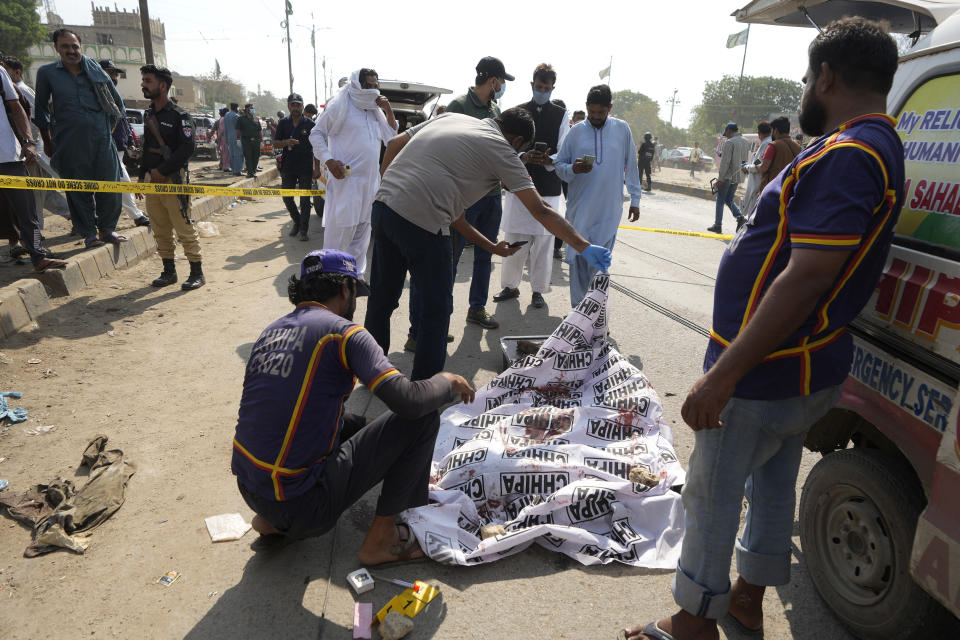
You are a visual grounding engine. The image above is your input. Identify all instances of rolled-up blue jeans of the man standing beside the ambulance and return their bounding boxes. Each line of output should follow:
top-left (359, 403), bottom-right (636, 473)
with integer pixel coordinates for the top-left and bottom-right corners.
top-left (673, 386), bottom-right (840, 619)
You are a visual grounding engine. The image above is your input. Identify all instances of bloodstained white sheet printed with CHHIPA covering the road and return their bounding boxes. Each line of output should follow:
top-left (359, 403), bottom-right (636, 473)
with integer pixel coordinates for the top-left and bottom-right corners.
top-left (403, 274), bottom-right (684, 569)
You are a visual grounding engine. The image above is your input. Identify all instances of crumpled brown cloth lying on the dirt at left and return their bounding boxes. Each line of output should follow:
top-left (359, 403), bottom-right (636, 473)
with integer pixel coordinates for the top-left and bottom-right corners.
top-left (0, 435), bottom-right (135, 558)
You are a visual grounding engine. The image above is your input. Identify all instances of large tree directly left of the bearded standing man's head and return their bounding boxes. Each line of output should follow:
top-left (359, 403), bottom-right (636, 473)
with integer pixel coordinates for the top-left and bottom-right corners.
top-left (690, 75), bottom-right (803, 149)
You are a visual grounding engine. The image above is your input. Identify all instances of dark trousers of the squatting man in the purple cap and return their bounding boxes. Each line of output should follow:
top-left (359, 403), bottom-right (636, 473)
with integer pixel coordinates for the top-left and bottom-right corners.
top-left (238, 404), bottom-right (440, 540)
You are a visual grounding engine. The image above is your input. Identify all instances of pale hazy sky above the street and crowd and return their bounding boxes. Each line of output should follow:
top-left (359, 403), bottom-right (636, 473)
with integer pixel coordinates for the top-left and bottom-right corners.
top-left (55, 0), bottom-right (816, 127)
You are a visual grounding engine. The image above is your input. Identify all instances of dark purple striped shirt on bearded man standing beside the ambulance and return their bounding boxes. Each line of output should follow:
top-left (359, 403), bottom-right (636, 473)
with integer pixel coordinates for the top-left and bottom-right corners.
top-left (704, 114), bottom-right (904, 400)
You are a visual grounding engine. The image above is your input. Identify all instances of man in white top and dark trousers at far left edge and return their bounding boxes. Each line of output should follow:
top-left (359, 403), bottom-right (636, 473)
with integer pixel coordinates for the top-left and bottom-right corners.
top-left (0, 61), bottom-right (67, 272)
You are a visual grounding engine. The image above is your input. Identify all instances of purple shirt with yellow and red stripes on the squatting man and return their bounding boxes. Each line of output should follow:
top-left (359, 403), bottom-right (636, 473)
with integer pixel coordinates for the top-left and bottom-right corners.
top-left (231, 302), bottom-right (400, 501)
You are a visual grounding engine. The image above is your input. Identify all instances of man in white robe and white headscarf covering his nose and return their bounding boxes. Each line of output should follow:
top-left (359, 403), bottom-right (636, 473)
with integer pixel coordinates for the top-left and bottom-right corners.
top-left (310, 69), bottom-right (397, 279)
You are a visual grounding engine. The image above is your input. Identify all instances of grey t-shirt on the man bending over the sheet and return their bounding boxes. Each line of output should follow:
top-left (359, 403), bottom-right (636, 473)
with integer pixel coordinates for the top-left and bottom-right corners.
top-left (376, 113), bottom-right (534, 235)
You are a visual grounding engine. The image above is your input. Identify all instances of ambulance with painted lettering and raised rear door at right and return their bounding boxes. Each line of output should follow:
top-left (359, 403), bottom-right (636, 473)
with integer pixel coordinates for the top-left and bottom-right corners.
top-left (733, 0), bottom-right (960, 640)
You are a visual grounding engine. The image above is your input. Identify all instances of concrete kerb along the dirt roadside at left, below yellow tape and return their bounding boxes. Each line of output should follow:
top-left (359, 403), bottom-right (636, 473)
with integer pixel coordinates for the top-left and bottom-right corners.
top-left (0, 167), bottom-right (279, 338)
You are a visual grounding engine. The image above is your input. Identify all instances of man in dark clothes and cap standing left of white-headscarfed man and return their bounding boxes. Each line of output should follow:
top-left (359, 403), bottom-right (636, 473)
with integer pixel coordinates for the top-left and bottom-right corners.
top-left (273, 93), bottom-right (314, 241)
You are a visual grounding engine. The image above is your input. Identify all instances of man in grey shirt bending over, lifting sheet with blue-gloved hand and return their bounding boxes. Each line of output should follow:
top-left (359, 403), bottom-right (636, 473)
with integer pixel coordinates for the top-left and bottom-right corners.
top-left (364, 108), bottom-right (610, 380)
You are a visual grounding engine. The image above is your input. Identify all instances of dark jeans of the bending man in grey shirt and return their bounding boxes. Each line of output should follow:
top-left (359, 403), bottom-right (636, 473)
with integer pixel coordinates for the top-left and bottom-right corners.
top-left (363, 201), bottom-right (453, 380)
